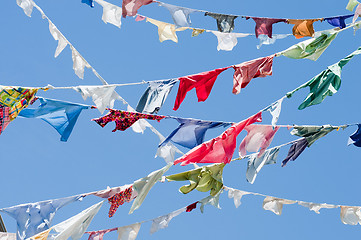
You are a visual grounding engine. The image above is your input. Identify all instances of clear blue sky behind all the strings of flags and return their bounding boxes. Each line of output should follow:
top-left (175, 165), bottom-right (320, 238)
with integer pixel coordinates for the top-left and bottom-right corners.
top-left (0, 0), bottom-right (361, 239)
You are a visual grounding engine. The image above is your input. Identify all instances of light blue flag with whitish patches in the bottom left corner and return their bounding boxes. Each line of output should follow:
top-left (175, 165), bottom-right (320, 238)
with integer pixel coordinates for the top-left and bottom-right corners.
top-left (0, 195), bottom-right (82, 240)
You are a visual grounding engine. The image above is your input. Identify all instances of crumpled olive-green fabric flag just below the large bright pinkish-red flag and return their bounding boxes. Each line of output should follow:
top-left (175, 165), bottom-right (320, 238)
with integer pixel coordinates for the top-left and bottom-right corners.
top-left (166, 163), bottom-right (225, 196)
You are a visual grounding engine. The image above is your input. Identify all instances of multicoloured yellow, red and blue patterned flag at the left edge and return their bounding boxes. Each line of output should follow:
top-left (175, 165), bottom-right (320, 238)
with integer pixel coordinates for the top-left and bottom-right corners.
top-left (0, 85), bottom-right (39, 121)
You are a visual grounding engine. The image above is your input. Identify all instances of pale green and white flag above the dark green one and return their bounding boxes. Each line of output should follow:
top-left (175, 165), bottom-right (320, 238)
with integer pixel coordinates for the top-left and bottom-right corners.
top-left (280, 30), bottom-right (338, 61)
